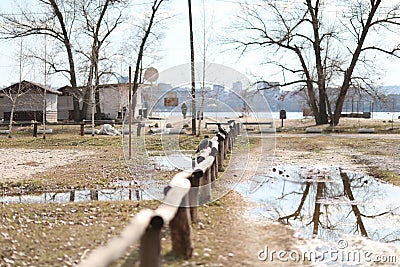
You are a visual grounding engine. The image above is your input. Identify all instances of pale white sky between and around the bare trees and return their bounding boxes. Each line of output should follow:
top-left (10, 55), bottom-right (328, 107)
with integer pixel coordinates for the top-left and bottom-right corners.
top-left (0, 0), bottom-right (400, 90)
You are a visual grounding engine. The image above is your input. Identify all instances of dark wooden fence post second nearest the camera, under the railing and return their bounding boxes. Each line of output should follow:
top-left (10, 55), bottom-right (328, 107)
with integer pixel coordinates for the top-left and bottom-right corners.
top-left (169, 195), bottom-right (193, 260)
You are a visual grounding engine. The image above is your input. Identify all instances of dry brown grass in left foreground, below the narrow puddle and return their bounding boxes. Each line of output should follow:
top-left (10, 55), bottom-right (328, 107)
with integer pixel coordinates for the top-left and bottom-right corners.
top-left (0, 201), bottom-right (158, 266)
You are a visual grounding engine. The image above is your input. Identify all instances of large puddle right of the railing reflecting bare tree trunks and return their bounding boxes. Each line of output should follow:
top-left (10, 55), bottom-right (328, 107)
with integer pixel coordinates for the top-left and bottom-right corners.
top-left (236, 165), bottom-right (400, 244)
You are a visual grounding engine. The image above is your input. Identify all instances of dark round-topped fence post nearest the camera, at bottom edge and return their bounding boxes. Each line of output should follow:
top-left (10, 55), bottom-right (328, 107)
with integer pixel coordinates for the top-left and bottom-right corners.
top-left (140, 216), bottom-right (164, 267)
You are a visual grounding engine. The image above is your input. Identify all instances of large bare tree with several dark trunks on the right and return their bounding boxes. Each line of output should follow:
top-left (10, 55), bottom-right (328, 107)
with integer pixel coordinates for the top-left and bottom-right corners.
top-left (232, 0), bottom-right (400, 125)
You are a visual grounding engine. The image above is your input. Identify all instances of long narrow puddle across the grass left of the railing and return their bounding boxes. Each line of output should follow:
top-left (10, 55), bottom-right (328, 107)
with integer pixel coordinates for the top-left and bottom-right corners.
top-left (0, 187), bottom-right (151, 203)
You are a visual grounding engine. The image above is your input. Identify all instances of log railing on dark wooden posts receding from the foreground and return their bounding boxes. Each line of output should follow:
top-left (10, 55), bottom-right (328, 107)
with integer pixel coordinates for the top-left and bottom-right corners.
top-left (78, 122), bottom-right (240, 267)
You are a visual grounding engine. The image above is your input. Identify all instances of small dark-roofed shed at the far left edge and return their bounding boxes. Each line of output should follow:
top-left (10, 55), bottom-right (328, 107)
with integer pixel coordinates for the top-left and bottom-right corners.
top-left (0, 80), bottom-right (61, 122)
